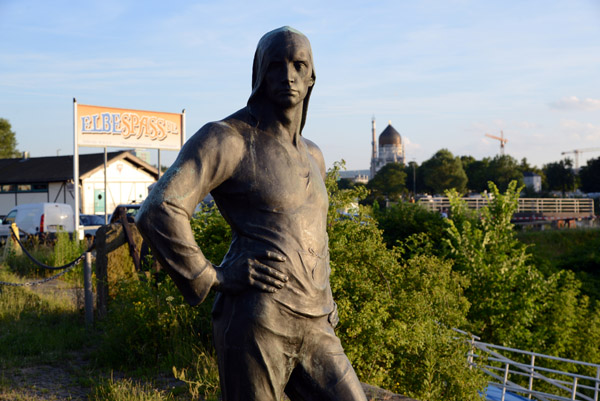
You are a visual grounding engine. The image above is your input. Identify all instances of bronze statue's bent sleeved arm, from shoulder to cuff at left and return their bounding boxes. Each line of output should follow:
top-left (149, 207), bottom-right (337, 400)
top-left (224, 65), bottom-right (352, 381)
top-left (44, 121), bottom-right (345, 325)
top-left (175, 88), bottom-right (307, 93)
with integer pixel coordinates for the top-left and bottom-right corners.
top-left (136, 123), bottom-right (244, 305)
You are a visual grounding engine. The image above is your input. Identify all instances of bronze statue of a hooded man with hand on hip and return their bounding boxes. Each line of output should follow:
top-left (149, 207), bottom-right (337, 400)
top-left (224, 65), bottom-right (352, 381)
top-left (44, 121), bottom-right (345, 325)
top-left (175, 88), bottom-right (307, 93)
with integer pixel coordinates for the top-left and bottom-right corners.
top-left (137, 27), bottom-right (366, 401)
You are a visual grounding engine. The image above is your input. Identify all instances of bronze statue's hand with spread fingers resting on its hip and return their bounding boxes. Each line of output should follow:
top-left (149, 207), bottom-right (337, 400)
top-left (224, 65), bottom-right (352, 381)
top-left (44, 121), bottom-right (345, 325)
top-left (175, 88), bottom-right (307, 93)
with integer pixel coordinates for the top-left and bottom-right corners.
top-left (215, 251), bottom-right (288, 294)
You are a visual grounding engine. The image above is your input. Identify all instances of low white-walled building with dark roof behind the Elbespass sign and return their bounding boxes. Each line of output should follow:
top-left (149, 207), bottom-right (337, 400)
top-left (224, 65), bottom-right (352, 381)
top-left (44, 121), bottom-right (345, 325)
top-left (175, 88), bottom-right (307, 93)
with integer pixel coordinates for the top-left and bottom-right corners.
top-left (0, 151), bottom-right (158, 215)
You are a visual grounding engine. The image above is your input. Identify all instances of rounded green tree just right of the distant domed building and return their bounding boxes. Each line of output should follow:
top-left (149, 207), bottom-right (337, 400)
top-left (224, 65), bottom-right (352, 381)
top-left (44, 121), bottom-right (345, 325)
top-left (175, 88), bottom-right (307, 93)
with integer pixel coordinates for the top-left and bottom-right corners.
top-left (421, 149), bottom-right (467, 194)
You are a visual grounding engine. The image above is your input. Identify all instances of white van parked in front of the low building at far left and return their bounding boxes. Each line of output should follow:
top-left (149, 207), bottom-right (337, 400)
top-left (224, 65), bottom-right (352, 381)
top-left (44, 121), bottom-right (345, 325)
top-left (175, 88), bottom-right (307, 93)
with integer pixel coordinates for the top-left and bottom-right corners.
top-left (0, 203), bottom-right (75, 242)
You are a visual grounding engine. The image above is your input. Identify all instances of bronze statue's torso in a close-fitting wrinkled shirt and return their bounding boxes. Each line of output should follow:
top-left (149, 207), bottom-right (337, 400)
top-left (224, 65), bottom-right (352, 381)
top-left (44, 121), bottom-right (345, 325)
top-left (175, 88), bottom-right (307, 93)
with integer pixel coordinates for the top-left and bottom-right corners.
top-left (211, 115), bottom-right (333, 316)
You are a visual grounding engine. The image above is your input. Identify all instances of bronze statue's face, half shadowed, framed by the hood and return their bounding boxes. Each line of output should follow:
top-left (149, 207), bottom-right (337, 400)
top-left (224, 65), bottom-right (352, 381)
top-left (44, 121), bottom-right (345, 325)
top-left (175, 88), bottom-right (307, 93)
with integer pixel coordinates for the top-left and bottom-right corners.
top-left (263, 35), bottom-right (314, 107)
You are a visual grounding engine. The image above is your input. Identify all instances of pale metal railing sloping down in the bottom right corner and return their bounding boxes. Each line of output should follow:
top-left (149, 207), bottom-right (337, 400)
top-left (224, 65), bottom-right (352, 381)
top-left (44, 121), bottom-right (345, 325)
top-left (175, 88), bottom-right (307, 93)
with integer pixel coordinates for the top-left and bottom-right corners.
top-left (454, 329), bottom-right (600, 401)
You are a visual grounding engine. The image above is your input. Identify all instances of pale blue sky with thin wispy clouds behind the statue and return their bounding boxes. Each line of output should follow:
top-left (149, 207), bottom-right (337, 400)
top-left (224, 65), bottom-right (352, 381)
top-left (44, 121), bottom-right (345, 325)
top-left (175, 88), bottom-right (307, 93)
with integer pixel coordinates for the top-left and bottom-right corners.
top-left (0, 0), bottom-right (600, 169)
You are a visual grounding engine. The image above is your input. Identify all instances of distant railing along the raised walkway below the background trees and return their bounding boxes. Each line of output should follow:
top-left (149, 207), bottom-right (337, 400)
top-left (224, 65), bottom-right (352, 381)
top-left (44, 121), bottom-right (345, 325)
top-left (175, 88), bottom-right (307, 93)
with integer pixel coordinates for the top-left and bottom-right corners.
top-left (419, 196), bottom-right (594, 216)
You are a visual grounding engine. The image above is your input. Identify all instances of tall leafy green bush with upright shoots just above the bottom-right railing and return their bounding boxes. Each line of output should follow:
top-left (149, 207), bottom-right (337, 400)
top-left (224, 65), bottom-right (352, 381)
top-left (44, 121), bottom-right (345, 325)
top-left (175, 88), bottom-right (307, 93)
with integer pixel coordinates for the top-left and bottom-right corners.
top-left (448, 182), bottom-right (600, 362)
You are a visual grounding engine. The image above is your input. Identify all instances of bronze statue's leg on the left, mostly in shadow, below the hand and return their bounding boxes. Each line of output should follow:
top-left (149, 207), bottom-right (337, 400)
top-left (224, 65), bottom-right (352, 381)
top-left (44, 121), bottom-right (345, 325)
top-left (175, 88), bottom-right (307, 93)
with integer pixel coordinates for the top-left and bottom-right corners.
top-left (213, 294), bottom-right (301, 401)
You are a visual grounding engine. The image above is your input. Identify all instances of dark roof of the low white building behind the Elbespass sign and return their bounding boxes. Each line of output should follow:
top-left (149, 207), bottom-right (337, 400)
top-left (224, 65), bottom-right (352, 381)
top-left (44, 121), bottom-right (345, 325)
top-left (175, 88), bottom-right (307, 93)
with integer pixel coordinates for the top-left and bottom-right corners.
top-left (0, 151), bottom-right (158, 184)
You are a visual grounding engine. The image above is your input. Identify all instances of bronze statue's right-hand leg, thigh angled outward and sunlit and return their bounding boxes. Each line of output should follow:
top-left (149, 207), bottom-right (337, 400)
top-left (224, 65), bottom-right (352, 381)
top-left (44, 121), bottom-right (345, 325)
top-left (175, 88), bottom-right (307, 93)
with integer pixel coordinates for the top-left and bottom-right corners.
top-left (285, 316), bottom-right (367, 401)
